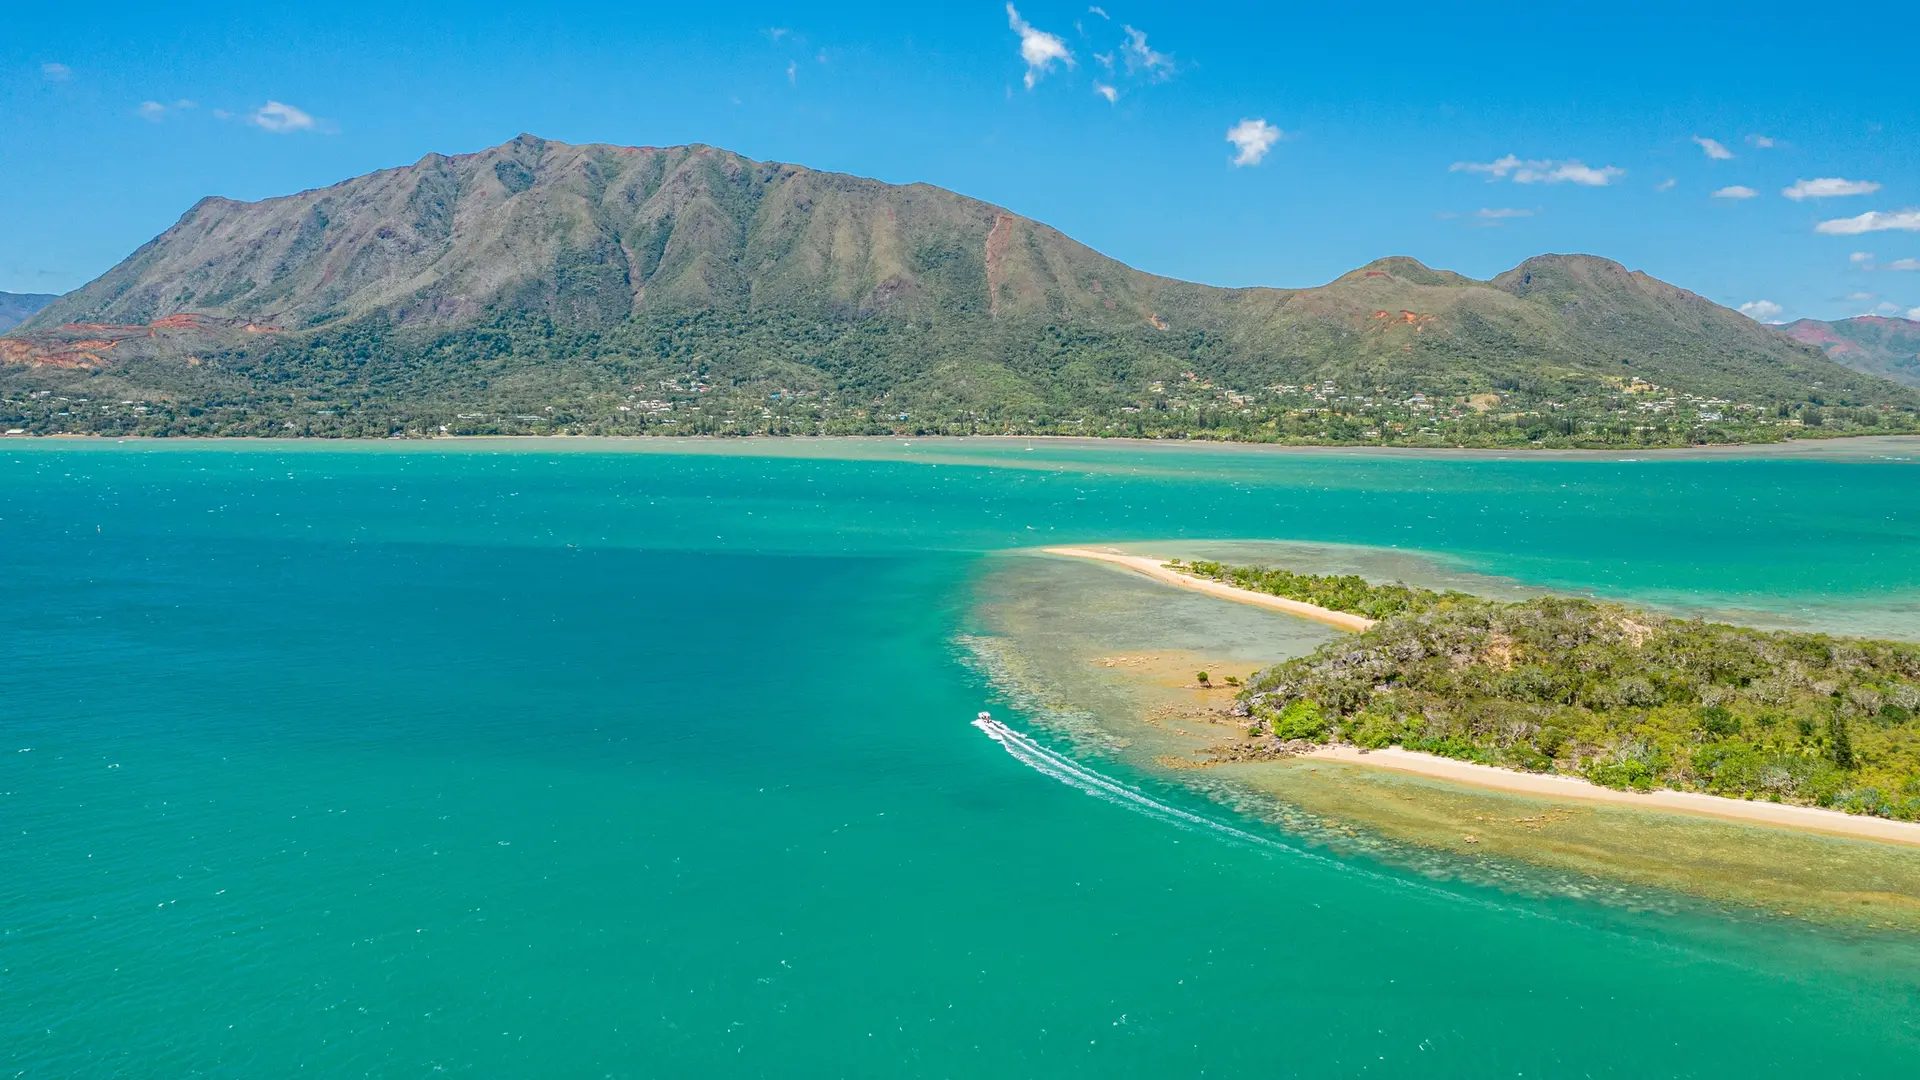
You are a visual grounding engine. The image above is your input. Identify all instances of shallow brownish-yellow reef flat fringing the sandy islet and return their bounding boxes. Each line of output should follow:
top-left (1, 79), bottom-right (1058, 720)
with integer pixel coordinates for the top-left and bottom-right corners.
top-left (970, 544), bottom-right (1920, 930)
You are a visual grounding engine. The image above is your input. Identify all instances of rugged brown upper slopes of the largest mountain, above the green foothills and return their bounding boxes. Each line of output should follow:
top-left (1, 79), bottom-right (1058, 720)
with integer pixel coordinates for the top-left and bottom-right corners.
top-left (18, 135), bottom-right (1190, 331)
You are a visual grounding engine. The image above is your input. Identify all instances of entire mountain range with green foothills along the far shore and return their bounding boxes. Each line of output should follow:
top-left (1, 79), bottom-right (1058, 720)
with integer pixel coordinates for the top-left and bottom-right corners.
top-left (0, 135), bottom-right (1920, 444)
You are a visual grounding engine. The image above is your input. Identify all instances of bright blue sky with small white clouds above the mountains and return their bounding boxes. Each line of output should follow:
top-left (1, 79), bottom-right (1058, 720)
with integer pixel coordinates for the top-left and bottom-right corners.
top-left (0, 0), bottom-right (1920, 319)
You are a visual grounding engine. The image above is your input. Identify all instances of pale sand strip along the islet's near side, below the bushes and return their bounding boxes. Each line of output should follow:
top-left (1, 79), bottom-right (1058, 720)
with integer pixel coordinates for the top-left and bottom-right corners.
top-left (1308, 746), bottom-right (1920, 847)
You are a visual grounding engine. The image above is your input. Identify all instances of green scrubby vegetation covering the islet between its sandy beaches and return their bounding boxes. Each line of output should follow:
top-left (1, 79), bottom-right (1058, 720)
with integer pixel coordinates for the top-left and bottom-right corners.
top-left (1206, 567), bottom-right (1920, 821)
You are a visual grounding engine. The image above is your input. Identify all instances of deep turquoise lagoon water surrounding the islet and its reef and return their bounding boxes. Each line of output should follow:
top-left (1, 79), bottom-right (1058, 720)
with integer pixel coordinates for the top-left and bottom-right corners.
top-left (0, 434), bottom-right (1920, 1076)
